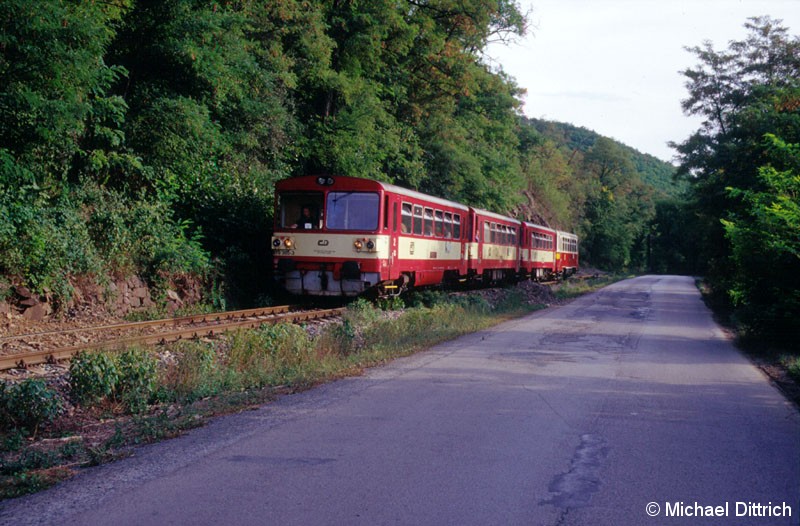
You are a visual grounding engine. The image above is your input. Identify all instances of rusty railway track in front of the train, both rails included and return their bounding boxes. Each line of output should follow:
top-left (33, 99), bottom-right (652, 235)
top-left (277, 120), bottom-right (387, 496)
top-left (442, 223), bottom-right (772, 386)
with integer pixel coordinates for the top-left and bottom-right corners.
top-left (0, 305), bottom-right (344, 371)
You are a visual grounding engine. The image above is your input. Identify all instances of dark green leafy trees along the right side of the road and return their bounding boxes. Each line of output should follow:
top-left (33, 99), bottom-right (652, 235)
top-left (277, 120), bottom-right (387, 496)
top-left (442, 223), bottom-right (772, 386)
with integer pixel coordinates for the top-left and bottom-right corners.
top-left (675, 17), bottom-right (800, 342)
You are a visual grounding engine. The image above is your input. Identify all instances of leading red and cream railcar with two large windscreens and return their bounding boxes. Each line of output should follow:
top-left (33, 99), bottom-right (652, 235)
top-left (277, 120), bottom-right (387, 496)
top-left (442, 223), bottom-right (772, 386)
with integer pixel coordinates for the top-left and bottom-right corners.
top-left (272, 176), bottom-right (469, 296)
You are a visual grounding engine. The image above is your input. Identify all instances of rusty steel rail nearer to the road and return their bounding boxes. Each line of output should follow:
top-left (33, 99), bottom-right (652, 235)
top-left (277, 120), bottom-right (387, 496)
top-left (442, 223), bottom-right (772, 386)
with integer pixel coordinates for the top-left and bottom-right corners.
top-left (0, 307), bottom-right (344, 370)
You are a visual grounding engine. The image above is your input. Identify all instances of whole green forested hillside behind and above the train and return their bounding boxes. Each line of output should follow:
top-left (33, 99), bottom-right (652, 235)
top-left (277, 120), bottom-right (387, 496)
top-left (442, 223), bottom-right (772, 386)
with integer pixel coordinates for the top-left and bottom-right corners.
top-left (0, 0), bottom-right (692, 310)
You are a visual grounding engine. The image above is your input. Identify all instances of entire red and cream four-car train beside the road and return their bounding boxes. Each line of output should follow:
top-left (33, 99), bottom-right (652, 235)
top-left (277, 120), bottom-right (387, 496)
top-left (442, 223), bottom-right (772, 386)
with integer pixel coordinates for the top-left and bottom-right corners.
top-left (272, 175), bottom-right (578, 296)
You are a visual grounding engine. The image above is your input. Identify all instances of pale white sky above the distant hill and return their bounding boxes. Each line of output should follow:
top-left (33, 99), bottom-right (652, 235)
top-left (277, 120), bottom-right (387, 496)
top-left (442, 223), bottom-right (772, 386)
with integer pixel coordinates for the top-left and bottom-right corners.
top-left (487, 0), bottom-right (800, 161)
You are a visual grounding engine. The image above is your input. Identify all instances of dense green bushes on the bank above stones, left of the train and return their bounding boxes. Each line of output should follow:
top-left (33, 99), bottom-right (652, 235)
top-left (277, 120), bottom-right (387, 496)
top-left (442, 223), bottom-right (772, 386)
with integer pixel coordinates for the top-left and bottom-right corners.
top-left (0, 177), bottom-right (210, 300)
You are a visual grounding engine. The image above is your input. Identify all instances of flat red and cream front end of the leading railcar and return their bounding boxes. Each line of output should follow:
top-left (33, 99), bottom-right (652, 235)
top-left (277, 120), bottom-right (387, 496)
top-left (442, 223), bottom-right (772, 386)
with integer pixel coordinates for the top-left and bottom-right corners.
top-left (272, 176), bottom-right (390, 296)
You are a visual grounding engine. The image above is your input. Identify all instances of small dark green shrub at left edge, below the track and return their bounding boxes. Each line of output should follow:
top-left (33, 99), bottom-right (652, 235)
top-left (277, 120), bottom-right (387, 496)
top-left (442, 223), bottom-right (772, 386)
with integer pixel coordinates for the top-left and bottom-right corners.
top-left (0, 378), bottom-right (64, 434)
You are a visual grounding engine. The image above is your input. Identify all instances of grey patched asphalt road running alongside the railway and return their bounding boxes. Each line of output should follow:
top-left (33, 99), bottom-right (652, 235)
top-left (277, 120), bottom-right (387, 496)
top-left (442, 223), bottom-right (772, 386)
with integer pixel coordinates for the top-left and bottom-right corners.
top-left (0, 276), bottom-right (800, 526)
